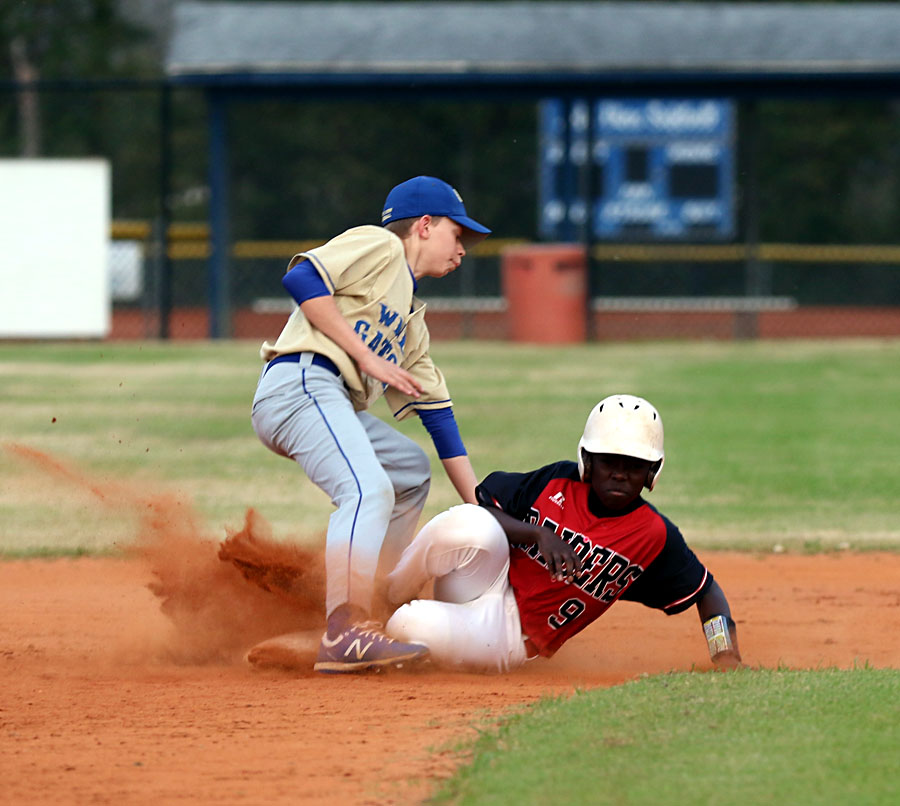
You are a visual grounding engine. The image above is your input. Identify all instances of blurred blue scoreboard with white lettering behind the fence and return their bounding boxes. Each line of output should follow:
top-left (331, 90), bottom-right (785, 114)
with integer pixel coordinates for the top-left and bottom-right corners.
top-left (538, 99), bottom-right (735, 241)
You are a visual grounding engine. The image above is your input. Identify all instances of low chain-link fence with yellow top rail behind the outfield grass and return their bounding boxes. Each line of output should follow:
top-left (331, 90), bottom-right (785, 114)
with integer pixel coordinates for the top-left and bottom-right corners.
top-left (110, 226), bottom-right (900, 341)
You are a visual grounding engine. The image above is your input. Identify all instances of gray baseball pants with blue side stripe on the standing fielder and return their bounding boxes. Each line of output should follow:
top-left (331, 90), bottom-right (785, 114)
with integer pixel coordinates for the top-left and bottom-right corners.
top-left (252, 353), bottom-right (431, 615)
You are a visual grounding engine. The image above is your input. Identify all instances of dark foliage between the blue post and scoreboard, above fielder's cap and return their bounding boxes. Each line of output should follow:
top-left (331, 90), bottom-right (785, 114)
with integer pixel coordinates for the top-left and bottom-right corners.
top-left (229, 99), bottom-right (537, 238)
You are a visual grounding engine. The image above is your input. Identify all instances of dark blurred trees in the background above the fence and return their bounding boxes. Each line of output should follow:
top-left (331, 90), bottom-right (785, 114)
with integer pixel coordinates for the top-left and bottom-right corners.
top-left (0, 0), bottom-right (900, 244)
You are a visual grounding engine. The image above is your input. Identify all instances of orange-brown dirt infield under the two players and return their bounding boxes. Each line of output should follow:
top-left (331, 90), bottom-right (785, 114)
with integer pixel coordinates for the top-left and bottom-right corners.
top-left (0, 552), bottom-right (900, 804)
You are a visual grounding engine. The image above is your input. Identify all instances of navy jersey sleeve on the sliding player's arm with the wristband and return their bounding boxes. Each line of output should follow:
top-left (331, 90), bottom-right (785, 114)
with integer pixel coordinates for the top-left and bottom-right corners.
top-left (622, 504), bottom-right (713, 616)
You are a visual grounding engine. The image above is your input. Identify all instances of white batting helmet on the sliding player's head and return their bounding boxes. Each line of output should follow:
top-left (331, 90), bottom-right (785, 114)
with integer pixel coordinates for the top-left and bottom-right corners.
top-left (578, 395), bottom-right (665, 490)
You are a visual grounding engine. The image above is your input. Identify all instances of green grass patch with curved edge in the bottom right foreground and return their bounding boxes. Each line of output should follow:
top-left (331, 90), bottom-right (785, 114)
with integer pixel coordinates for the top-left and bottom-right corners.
top-left (433, 668), bottom-right (900, 806)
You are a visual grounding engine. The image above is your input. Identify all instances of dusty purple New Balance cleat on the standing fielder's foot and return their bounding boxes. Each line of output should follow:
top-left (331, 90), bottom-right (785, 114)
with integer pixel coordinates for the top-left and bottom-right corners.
top-left (313, 621), bottom-right (428, 673)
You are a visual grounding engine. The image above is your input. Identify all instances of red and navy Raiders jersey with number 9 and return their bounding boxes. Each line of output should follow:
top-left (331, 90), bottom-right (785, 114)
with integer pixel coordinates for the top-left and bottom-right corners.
top-left (476, 462), bottom-right (713, 657)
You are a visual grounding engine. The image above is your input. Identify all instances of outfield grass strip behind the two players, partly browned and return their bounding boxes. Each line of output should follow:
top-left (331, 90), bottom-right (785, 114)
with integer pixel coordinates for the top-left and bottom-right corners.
top-left (0, 341), bottom-right (900, 554)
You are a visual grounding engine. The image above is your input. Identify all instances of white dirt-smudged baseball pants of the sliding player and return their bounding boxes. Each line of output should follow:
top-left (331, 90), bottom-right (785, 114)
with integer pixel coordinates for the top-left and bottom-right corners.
top-left (385, 504), bottom-right (527, 672)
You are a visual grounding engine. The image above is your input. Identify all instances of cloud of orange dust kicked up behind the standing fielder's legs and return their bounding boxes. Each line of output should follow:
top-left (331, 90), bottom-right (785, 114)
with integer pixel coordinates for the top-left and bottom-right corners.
top-left (4, 444), bottom-right (325, 664)
